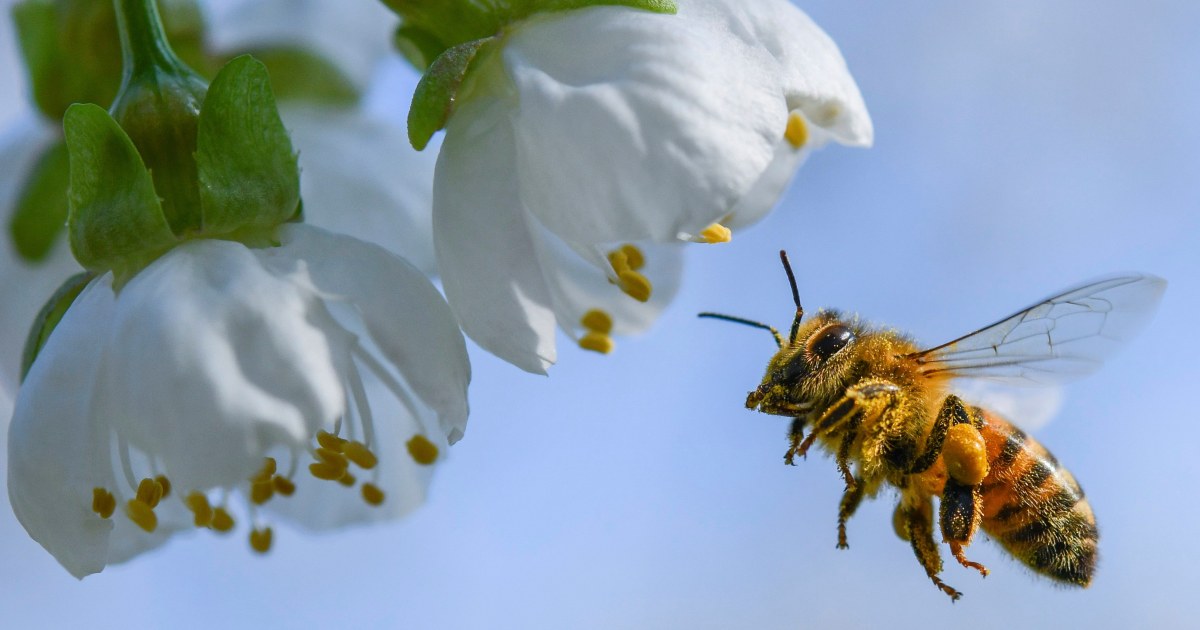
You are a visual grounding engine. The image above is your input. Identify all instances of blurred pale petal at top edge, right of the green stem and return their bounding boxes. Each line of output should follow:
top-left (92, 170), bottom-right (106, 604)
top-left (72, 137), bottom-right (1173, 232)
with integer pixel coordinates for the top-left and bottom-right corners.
top-left (208, 0), bottom-right (397, 88)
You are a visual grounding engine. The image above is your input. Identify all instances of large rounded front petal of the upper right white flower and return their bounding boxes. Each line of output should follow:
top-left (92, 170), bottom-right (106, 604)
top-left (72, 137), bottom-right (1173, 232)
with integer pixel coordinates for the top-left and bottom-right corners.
top-left (501, 5), bottom-right (788, 242)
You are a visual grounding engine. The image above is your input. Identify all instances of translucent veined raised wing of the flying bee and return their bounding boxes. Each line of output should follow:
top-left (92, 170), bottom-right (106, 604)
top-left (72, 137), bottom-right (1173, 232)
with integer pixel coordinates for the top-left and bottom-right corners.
top-left (907, 274), bottom-right (1166, 385)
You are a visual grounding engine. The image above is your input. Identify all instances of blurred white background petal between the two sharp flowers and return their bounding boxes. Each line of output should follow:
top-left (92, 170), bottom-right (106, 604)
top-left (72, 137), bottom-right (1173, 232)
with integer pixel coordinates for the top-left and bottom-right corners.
top-left (281, 103), bottom-right (437, 275)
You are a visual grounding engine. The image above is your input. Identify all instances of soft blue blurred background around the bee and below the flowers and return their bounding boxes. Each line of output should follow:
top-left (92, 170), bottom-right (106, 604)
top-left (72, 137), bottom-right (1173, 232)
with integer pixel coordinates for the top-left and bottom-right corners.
top-left (0, 0), bottom-right (1200, 629)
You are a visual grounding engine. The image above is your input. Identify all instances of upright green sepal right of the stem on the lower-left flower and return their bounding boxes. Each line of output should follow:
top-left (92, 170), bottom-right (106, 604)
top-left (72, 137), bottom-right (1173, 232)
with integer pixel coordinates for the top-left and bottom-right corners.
top-left (196, 55), bottom-right (300, 235)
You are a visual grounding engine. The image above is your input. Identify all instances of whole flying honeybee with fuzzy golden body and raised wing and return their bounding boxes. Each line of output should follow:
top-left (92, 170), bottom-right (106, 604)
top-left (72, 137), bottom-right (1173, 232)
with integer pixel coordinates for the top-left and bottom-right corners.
top-left (700, 252), bottom-right (1166, 600)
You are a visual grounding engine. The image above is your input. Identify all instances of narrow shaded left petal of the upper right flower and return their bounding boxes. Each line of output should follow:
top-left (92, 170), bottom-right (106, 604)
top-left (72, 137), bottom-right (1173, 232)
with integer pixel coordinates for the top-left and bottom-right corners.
top-left (433, 87), bottom-right (556, 373)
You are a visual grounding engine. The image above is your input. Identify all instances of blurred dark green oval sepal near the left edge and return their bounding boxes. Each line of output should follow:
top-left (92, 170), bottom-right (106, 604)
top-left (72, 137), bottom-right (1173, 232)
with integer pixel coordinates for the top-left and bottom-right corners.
top-left (8, 140), bottom-right (71, 263)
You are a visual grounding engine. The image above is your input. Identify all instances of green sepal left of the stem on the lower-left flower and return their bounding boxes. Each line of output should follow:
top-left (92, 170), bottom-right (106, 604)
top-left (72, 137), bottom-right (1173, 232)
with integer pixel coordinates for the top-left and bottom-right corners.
top-left (62, 103), bottom-right (175, 282)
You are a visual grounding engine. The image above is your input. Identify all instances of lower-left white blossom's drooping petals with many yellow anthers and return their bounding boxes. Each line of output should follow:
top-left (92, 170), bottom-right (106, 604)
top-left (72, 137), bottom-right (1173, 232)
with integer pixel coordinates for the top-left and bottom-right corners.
top-left (8, 224), bottom-right (470, 577)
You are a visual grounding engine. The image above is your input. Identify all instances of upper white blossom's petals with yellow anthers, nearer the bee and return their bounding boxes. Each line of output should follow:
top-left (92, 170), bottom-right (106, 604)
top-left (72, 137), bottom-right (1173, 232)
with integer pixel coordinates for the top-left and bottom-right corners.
top-left (433, 0), bottom-right (872, 372)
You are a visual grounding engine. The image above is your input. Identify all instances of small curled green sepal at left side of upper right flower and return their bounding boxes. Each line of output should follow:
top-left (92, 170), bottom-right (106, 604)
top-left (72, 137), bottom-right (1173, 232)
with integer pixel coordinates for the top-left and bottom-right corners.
top-left (408, 37), bottom-right (497, 151)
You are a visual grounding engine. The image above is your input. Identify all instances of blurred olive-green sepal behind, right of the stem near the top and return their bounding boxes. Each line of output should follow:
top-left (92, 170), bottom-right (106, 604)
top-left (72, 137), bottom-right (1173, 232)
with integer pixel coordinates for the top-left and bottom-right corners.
top-left (234, 47), bottom-right (361, 106)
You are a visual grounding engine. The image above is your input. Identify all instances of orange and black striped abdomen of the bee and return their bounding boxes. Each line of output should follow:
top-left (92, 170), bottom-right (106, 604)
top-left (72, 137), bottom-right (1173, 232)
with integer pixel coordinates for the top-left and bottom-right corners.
top-left (980, 412), bottom-right (1098, 587)
